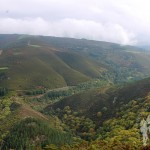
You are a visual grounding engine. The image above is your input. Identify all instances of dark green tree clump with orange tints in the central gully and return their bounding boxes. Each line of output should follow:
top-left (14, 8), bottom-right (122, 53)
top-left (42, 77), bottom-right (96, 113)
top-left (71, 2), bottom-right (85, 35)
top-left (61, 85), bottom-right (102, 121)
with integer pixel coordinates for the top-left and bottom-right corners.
top-left (49, 106), bottom-right (97, 141)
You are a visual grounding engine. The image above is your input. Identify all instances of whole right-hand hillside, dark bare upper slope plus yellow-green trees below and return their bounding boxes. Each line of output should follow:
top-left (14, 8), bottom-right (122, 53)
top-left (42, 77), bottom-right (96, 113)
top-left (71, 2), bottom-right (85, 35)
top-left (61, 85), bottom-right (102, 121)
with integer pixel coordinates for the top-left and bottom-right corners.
top-left (44, 78), bottom-right (150, 150)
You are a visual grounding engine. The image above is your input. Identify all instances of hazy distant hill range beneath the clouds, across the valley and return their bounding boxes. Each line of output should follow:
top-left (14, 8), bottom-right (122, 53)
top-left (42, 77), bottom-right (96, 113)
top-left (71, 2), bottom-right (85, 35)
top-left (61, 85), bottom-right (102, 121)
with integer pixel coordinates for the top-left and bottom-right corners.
top-left (0, 34), bottom-right (150, 90)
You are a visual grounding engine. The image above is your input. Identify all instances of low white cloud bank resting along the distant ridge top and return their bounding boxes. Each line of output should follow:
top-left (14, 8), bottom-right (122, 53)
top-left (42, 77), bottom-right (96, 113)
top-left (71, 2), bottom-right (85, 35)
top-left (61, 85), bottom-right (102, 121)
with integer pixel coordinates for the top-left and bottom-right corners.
top-left (0, 18), bottom-right (136, 44)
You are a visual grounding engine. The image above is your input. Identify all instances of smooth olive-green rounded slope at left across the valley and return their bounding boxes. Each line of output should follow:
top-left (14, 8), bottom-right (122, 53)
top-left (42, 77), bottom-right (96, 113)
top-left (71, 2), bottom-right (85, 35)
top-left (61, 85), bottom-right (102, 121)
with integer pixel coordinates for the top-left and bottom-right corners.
top-left (0, 38), bottom-right (98, 89)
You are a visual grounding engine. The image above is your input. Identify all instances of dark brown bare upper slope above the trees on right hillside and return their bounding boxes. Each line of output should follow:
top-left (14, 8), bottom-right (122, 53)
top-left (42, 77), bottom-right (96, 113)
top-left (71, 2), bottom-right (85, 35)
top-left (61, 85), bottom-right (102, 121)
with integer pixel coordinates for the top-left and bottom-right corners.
top-left (46, 78), bottom-right (150, 124)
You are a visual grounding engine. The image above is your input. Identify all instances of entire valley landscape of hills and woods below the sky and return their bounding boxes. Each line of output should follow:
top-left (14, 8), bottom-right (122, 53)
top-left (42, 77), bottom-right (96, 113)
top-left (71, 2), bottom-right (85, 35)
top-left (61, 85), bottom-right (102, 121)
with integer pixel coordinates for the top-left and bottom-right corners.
top-left (0, 34), bottom-right (150, 150)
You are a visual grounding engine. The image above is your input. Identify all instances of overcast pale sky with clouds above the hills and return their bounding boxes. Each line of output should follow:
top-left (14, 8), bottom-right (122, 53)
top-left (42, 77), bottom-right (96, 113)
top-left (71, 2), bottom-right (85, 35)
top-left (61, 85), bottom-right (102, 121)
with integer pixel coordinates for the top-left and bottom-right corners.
top-left (0, 0), bottom-right (150, 45)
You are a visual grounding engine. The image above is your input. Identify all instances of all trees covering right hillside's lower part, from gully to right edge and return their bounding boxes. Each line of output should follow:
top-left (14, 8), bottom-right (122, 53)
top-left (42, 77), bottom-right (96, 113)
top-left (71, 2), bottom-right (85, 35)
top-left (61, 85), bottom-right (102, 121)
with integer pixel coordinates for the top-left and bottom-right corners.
top-left (42, 95), bottom-right (150, 150)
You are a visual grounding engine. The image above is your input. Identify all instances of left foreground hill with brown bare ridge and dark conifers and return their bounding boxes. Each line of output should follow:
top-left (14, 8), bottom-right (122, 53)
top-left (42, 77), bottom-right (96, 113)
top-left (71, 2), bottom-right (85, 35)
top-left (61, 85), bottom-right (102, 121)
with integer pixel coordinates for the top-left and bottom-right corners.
top-left (0, 93), bottom-right (73, 150)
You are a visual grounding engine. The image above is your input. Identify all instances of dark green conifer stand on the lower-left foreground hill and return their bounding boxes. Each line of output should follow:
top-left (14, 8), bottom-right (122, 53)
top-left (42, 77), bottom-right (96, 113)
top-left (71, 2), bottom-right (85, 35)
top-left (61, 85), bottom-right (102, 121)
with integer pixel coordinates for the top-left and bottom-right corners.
top-left (2, 118), bottom-right (73, 150)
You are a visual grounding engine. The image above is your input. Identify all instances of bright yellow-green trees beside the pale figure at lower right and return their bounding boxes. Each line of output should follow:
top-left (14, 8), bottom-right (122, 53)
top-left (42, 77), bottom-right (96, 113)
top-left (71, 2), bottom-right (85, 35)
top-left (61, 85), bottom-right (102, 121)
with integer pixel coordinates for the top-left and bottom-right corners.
top-left (98, 95), bottom-right (150, 149)
